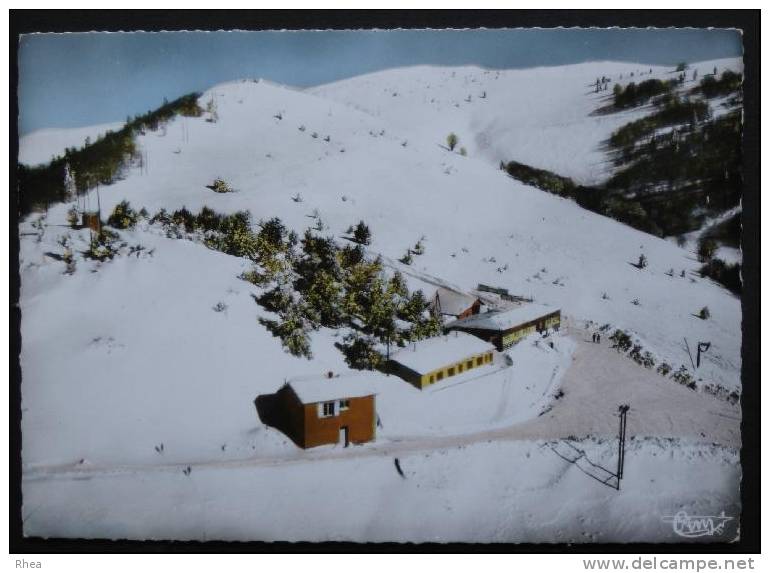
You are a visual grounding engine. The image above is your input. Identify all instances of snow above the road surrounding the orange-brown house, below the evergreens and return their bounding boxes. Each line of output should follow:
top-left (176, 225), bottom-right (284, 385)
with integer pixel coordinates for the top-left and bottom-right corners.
top-left (21, 217), bottom-right (572, 468)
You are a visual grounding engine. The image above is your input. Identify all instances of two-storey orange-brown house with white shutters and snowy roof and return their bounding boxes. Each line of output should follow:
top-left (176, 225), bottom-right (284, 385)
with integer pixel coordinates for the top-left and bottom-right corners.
top-left (268, 374), bottom-right (377, 448)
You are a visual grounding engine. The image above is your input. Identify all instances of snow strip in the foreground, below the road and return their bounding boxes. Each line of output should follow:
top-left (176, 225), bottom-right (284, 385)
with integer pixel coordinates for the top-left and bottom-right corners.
top-left (23, 439), bottom-right (740, 543)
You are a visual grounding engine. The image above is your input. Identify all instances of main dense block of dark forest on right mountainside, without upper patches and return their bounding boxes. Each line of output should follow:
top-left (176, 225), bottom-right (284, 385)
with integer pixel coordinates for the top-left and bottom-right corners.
top-left (504, 106), bottom-right (743, 240)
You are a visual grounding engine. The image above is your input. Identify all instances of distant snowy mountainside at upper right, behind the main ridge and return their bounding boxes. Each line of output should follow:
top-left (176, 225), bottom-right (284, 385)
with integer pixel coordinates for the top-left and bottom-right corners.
top-left (309, 59), bottom-right (743, 184)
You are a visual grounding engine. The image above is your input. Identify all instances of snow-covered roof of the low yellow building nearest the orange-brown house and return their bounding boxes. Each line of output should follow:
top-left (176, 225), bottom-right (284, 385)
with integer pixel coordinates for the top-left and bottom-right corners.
top-left (390, 332), bottom-right (495, 374)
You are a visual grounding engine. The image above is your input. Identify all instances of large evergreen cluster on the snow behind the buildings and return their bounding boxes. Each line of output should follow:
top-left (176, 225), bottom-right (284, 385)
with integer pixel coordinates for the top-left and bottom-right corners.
top-left (145, 207), bottom-right (442, 362)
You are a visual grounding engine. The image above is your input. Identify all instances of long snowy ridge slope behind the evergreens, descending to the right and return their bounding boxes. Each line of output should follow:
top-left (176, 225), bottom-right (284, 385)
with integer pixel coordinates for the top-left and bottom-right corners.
top-left (43, 75), bottom-right (740, 394)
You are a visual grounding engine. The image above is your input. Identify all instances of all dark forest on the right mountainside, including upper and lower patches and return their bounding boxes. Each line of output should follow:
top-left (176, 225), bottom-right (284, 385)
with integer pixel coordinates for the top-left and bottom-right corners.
top-left (502, 72), bottom-right (743, 292)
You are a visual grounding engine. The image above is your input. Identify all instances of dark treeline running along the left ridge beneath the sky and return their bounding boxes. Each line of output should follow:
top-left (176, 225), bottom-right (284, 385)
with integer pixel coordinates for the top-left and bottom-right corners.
top-left (18, 93), bottom-right (203, 215)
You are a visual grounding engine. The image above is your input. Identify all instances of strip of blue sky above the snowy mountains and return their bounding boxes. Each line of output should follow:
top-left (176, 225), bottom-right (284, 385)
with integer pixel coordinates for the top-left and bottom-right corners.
top-left (19, 29), bottom-right (742, 134)
